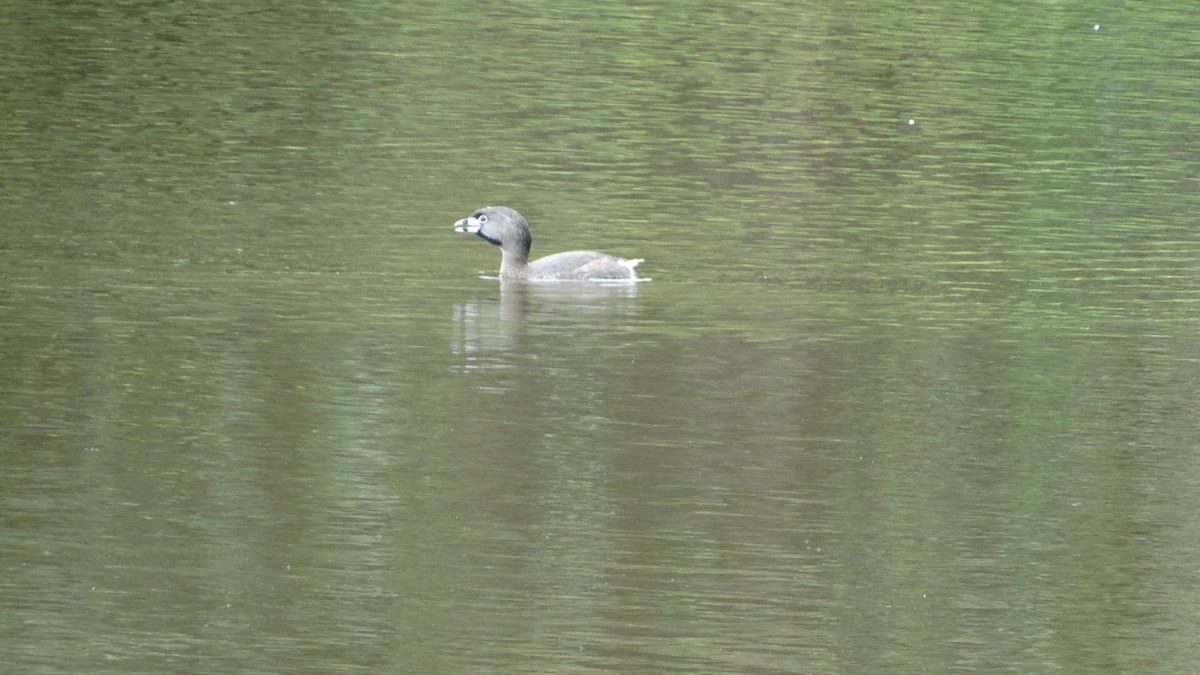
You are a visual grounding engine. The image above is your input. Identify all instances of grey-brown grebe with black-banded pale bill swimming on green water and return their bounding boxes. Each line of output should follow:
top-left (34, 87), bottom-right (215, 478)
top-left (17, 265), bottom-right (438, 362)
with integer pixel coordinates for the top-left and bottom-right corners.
top-left (454, 207), bottom-right (644, 281)
